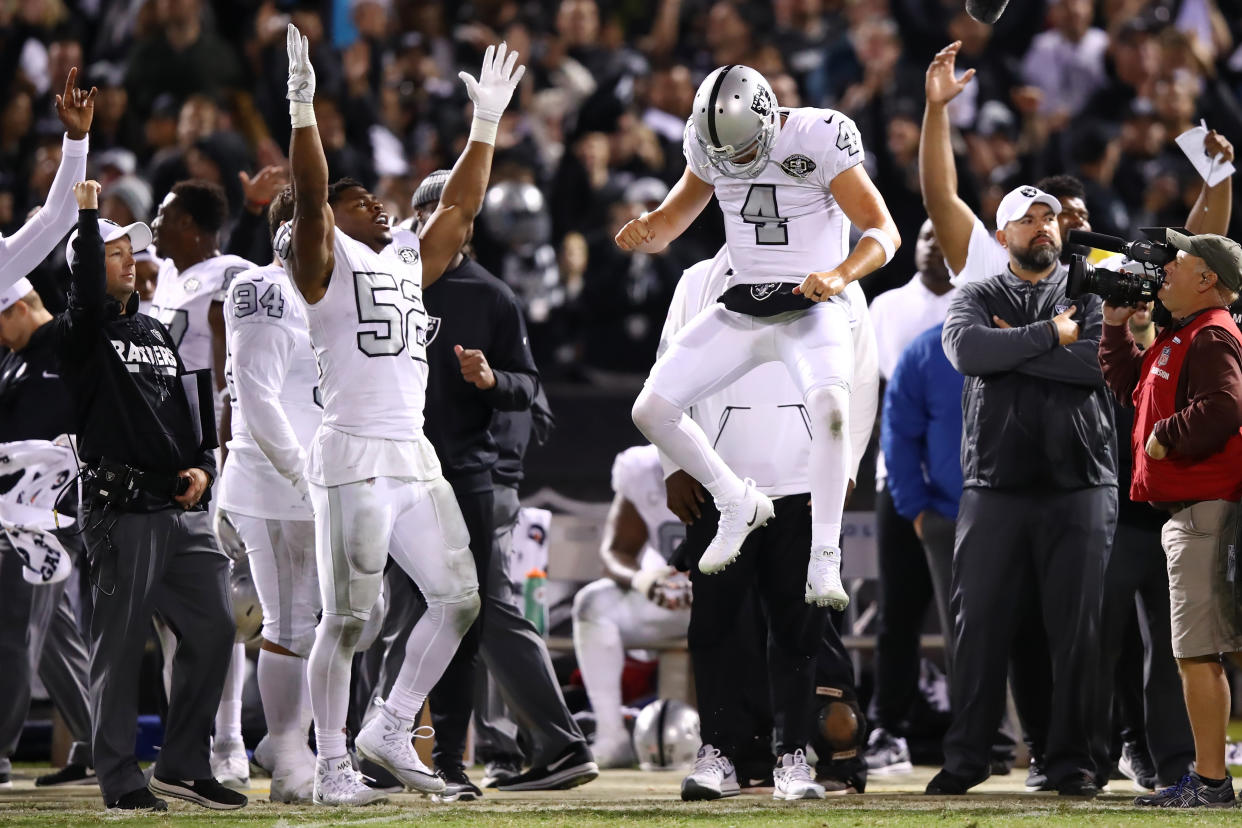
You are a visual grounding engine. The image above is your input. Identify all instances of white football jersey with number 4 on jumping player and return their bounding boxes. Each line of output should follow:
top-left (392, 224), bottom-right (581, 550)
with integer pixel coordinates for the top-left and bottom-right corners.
top-left (683, 107), bottom-right (863, 287)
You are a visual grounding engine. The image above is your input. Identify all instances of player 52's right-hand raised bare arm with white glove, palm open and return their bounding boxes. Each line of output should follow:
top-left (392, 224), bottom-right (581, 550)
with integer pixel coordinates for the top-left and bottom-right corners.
top-left (420, 43), bottom-right (527, 287)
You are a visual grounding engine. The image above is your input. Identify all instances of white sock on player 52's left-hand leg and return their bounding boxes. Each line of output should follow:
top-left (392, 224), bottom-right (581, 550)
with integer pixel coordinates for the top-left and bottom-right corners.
top-left (307, 613), bottom-right (363, 760)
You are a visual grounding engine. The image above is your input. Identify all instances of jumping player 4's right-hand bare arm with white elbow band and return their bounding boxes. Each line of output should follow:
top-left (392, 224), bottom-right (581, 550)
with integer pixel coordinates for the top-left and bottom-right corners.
top-left (794, 164), bottom-right (902, 302)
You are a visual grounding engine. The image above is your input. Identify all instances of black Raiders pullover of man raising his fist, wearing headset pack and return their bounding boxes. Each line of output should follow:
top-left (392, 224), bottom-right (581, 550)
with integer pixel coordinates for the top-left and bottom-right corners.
top-left (50, 210), bottom-right (216, 508)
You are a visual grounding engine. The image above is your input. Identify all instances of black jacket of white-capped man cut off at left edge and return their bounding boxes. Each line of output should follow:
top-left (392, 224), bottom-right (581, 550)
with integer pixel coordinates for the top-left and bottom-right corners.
top-left (0, 323), bottom-right (76, 443)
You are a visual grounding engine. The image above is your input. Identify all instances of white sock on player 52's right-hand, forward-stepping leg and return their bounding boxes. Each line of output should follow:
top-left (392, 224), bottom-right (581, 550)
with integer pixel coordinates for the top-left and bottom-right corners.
top-left (385, 595), bottom-right (478, 719)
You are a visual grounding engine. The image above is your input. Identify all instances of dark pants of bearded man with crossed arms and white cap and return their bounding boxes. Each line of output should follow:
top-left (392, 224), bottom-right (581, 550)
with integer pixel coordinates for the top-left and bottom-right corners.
top-left (944, 487), bottom-right (1117, 785)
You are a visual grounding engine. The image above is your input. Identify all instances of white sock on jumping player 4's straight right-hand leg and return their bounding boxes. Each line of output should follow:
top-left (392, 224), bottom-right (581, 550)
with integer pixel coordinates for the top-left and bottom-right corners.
top-left (806, 385), bottom-right (851, 549)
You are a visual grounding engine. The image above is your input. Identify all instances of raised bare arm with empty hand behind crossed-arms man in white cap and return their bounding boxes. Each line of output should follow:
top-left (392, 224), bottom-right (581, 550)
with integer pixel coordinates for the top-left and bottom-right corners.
top-left (919, 41), bottom-right (975, 273)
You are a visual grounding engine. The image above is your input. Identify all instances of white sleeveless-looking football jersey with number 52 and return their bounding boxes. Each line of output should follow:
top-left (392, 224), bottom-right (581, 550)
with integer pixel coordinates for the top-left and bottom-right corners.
top-left (298, 227), bottom-right (440, 485)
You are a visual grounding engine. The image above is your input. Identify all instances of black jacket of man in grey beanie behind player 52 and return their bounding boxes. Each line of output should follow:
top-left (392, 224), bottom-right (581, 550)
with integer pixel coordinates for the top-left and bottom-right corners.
top-left (422, 258), bottom-right (539, 492)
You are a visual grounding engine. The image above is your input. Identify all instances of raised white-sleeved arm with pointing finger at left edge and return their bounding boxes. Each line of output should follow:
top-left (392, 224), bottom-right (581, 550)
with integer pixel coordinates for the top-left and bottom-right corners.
top-left (0, 67), bottom-right (97, 290)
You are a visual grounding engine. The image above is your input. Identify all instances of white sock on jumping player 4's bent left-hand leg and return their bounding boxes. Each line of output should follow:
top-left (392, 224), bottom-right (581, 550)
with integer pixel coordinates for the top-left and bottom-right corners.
top-left (633, 387), bottom-right (746, 502)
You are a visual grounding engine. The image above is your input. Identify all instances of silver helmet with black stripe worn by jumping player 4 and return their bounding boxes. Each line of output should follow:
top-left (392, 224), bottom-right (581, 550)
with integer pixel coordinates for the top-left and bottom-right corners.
top-left (687, 63), bottom-right (780, 179)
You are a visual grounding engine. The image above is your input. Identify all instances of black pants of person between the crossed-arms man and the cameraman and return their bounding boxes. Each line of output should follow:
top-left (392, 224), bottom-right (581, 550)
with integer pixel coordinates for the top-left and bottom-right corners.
top-left (1095, 524), bottom-right (1195, 785)
